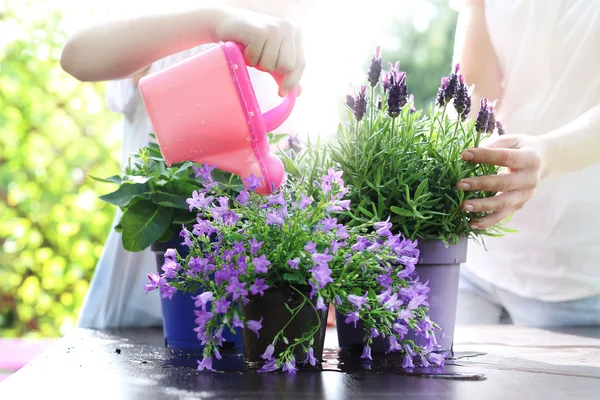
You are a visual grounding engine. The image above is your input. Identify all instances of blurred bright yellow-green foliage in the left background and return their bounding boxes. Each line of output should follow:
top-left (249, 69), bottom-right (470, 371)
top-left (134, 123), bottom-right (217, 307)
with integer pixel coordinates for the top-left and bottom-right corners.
top-left (0, 9), bottom-right (120, 337)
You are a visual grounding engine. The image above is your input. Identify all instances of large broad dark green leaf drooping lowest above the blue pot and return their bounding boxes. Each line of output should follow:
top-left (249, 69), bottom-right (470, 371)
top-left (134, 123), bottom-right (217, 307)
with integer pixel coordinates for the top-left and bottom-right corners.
top-left (121, 201), bottom-right (171, 252)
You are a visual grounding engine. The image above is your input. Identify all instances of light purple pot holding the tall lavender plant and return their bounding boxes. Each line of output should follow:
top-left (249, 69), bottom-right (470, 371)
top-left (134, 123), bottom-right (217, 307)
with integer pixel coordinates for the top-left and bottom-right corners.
top-left (336, 237), bottom-right (468, 355)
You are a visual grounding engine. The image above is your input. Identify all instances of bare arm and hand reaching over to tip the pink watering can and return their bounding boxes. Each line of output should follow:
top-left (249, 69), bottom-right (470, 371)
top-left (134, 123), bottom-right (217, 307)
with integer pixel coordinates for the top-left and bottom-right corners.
top-left (61, 5), bottom-right (304, 95)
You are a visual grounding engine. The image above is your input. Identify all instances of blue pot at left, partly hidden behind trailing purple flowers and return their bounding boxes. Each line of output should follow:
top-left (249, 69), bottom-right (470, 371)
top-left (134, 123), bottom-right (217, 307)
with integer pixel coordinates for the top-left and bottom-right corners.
top-left (152, 237), bottom-right (243, 352)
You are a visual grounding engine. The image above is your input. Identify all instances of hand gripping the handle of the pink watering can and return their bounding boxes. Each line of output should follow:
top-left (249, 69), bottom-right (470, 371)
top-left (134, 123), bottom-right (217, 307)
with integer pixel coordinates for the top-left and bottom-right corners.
top-left (215, 8), bottom-right (305, 96)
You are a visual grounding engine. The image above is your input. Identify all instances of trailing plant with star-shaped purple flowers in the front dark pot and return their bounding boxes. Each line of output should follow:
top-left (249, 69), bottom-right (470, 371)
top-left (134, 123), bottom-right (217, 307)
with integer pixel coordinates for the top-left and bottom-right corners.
top-left (145, 166), bottom-right (443, 374)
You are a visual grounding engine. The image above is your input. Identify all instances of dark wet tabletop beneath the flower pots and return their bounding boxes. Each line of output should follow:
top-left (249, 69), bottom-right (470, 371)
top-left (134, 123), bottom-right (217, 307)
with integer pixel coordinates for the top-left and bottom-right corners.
top-left (0, 326), bottom-right (600, 400)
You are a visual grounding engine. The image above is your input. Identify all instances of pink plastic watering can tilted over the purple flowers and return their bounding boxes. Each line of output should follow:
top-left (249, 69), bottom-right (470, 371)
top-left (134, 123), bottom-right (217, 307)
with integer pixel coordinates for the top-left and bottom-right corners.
top-left (139, 42), bottom-right (296, 194)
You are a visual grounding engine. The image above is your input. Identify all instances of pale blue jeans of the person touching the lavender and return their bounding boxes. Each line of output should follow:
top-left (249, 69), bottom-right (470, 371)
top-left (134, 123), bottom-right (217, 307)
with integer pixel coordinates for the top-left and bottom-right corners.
top-left (456, 268), bottom-right (600, 327)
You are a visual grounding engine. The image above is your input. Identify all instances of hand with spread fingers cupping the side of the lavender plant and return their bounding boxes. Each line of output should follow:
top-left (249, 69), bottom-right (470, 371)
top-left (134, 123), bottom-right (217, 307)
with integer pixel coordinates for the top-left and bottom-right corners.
top-left (457, 135), bottom-right (545, 229)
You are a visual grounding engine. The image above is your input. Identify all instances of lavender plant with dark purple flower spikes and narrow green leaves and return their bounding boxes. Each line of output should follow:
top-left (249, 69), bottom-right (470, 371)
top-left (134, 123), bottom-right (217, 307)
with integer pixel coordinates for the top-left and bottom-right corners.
top-left (314, 48), bottom-right (507, 243)
